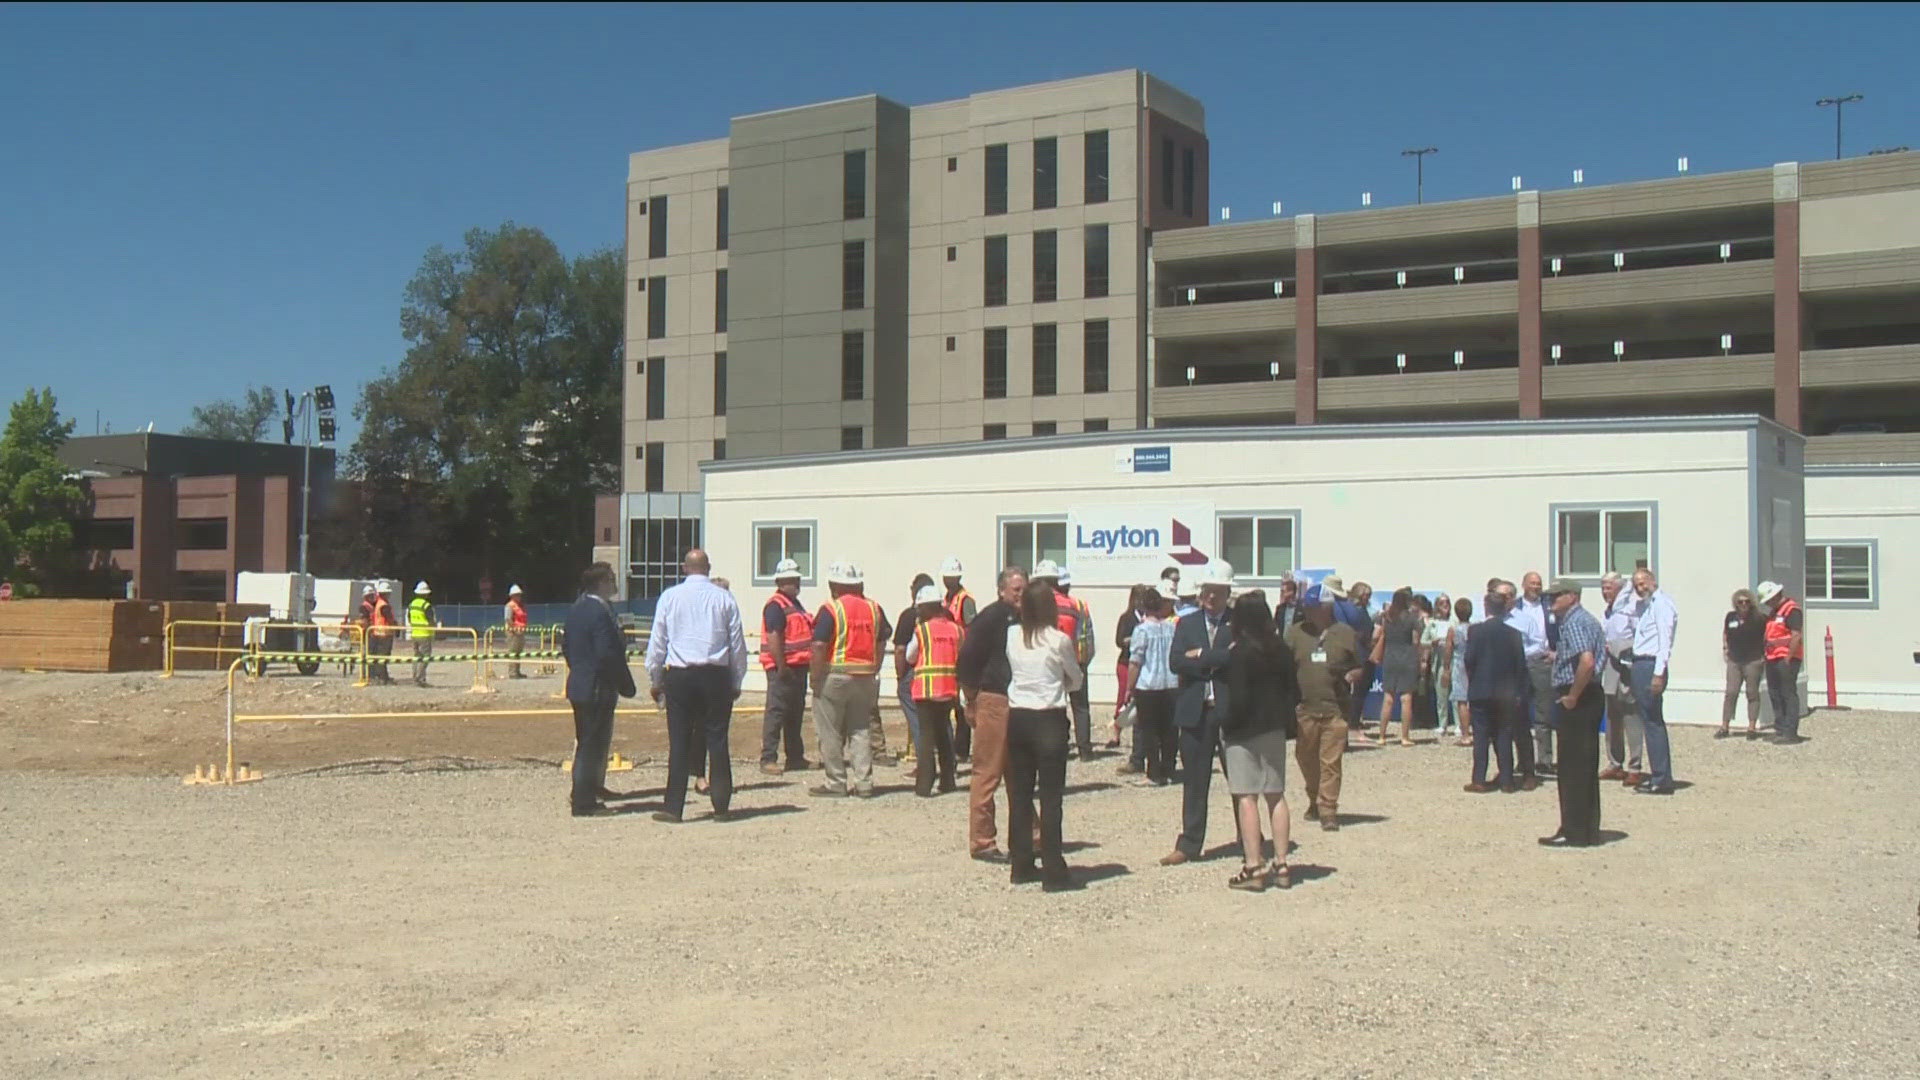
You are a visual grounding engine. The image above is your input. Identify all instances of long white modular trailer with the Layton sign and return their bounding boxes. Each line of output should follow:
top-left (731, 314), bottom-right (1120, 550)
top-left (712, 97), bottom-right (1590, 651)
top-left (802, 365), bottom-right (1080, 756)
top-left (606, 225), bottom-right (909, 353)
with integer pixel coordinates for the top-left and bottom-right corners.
top-left (703, 415), bottom-right (1805, 723)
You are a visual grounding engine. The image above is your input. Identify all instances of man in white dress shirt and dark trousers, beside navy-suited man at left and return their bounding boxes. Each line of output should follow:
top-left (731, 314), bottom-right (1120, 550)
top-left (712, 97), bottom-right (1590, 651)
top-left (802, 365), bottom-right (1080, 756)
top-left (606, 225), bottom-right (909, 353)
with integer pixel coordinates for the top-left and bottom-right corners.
top-left (647, 548), bottom-right (747, 822)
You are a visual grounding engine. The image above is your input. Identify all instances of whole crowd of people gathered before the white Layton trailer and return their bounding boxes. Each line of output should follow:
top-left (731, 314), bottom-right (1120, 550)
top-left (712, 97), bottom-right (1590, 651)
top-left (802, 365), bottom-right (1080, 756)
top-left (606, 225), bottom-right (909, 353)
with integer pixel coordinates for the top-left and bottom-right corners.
top-left (564, 550), bottom-right (1803, 892)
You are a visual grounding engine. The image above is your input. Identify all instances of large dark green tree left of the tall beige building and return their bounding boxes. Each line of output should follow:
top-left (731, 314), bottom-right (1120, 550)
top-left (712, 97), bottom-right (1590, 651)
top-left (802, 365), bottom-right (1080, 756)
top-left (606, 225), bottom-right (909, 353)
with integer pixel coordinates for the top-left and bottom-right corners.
top-left (334, 223), bottom-right (624, 598)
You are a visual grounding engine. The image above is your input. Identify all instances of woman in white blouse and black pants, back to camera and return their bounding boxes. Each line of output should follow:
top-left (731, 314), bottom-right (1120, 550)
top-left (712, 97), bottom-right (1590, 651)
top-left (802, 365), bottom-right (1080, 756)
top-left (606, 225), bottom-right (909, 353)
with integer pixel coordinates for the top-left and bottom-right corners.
top-left (1006, 582), bottom-right (1083, 892)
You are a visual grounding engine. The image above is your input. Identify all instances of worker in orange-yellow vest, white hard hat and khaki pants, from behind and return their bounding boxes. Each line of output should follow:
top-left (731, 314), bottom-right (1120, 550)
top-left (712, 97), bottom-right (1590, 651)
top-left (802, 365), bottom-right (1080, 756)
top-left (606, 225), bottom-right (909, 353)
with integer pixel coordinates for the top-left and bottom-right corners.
top-left (808, 563), bottom-right (893, 798)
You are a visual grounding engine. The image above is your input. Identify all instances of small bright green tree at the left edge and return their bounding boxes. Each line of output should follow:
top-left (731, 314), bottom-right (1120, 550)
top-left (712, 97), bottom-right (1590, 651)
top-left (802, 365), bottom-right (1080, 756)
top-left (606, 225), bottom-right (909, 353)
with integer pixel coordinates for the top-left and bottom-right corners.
top-left (0, 388), bottom-right (86, 596)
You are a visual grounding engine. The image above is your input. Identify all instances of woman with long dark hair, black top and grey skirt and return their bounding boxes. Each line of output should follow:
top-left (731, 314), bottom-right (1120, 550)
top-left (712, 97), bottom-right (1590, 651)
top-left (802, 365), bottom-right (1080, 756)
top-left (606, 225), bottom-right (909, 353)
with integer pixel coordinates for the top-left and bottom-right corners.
top-left (1219, 590), bottom-right (1300, 892)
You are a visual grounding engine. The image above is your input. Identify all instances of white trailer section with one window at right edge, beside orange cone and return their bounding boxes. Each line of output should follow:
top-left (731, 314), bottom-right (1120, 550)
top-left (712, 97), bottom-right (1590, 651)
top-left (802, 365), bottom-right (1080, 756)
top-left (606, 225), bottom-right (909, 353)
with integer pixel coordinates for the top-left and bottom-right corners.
top-left (1804, 463), bottom-right (1920, 711)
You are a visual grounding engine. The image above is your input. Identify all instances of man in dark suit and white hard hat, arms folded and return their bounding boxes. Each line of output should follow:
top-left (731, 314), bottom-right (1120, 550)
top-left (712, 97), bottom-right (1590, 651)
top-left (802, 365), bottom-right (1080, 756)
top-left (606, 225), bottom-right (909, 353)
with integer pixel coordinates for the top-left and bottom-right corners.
top-left (1160, 563), bottom-right (1233, 867)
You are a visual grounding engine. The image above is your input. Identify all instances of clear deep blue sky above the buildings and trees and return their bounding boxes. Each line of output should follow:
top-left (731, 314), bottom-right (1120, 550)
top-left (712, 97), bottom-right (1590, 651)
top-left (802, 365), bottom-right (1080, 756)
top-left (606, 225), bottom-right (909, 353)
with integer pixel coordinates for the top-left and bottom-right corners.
top-left (0, 4), bottom-right (1920, 438)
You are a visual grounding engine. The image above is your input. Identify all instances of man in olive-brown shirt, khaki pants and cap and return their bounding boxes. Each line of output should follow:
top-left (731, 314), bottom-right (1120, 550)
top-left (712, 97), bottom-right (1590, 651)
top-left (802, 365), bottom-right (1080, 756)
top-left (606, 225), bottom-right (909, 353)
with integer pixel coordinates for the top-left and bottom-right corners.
top-left (1286, 586), bottom-right (1361, 832)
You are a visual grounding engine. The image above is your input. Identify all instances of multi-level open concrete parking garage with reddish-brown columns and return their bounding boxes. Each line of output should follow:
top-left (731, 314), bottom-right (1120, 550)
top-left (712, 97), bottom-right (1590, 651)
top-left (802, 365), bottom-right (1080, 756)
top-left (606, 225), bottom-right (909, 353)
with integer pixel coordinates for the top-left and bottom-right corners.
top-left (1150, 154), bottom-right (1920, 461)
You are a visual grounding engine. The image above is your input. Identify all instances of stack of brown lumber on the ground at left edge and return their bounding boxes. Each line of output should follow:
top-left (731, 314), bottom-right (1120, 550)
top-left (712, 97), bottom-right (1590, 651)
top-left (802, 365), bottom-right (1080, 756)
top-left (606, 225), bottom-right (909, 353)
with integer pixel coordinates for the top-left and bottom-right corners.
top-left (0, 600), bottom-right (167, 671)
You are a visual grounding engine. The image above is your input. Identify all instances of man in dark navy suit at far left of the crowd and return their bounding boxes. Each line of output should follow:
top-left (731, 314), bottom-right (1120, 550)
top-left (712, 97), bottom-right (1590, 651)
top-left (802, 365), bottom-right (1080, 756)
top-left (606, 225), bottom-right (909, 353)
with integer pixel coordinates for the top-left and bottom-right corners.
top-left (563, 563), bottom-right (639, 817)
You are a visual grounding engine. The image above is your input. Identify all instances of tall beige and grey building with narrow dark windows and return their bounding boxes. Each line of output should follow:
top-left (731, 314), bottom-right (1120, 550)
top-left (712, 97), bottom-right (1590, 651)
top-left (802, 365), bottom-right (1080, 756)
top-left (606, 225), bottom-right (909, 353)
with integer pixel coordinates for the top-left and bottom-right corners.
top-left (620, 71), bottom-right (1208, 594)
